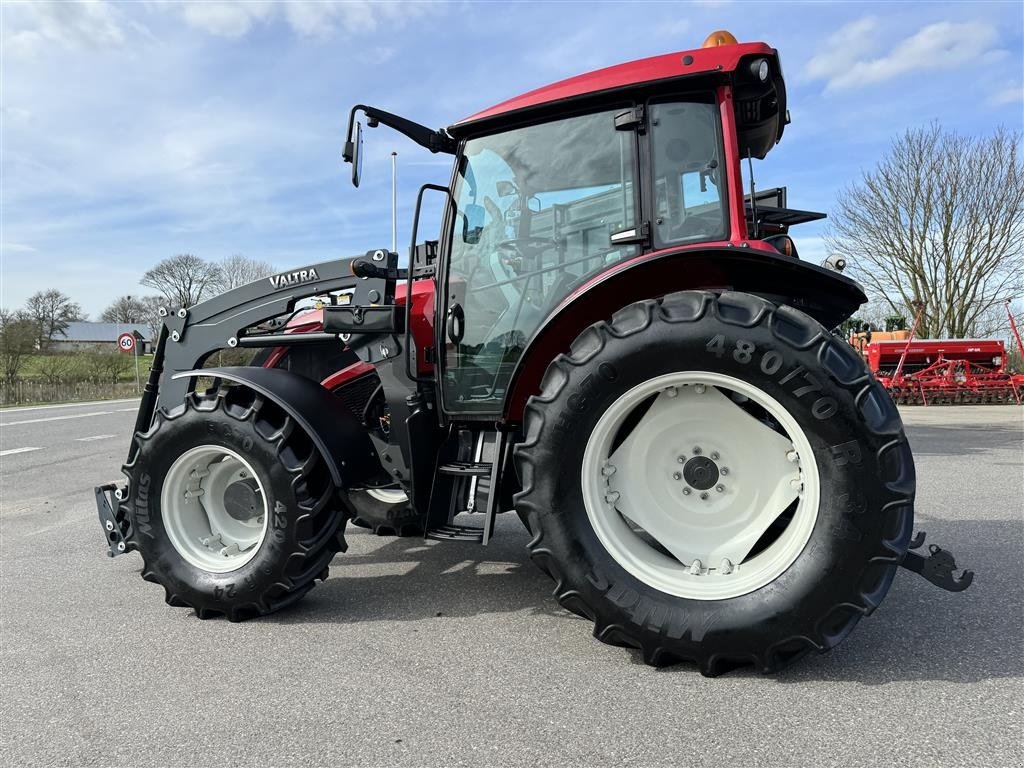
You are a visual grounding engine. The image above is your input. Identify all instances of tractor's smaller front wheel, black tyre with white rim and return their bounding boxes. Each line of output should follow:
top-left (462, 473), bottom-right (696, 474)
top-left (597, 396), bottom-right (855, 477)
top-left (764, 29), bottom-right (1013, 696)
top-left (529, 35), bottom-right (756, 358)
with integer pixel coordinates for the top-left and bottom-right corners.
top-left (124, 387), bottom-right (345, 622)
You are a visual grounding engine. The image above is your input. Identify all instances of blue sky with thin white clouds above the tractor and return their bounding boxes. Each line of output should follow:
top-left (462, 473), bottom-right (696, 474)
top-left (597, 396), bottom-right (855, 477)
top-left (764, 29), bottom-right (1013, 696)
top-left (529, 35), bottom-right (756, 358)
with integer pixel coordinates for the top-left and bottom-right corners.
top-left (0, 0), bottom-right (1024, 316)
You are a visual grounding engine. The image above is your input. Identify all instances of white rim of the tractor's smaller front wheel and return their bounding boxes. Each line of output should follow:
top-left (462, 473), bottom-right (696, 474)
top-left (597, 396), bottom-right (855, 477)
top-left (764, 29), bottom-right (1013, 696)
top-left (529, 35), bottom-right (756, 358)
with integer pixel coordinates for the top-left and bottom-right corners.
top-left (160, 445), bottom-right (269, 573)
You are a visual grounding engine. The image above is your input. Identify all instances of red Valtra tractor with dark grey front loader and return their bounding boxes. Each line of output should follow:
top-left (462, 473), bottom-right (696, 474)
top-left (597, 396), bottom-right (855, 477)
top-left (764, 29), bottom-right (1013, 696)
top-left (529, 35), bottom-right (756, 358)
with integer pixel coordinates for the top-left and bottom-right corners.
top-left (96, 33), bottom-right (971, 675)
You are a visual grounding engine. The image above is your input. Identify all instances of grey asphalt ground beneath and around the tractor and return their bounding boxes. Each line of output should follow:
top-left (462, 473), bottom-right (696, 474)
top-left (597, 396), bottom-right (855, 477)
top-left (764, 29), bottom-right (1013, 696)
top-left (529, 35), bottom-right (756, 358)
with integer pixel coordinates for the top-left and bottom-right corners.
top-left (0, 402), bottom-right (1024, 768)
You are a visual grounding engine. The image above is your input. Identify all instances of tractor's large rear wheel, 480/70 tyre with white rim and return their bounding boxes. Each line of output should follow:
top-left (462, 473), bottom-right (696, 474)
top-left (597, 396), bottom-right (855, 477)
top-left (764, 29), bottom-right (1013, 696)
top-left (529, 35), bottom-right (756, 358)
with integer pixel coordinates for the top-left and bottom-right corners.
top-left (515, 292), bottom-right (914, 675)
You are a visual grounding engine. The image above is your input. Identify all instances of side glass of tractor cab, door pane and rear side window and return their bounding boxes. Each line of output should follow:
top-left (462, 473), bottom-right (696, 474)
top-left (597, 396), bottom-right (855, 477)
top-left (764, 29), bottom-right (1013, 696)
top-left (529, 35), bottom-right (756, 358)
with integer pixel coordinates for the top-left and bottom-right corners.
top-left (443, 102), bottom-right (724, 413)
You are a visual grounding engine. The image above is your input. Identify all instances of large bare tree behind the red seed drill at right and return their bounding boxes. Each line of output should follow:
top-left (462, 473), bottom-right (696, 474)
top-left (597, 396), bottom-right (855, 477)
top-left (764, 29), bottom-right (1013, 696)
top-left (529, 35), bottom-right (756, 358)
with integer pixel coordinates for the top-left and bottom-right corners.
top-left (825, 124), bottom-right (1024, 338)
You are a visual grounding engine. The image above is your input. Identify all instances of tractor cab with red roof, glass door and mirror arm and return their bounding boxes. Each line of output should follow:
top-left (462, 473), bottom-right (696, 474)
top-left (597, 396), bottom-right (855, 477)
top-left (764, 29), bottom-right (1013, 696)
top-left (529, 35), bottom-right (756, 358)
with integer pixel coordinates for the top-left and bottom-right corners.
top-left (344, 32), bottom-right (795, 417)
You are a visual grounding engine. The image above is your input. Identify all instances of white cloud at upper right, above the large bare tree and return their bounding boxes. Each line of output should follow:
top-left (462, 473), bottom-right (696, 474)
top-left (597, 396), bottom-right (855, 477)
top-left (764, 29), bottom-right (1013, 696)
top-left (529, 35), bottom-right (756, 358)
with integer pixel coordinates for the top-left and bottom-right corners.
top-left (805, 16), bottom-right (1005, 90)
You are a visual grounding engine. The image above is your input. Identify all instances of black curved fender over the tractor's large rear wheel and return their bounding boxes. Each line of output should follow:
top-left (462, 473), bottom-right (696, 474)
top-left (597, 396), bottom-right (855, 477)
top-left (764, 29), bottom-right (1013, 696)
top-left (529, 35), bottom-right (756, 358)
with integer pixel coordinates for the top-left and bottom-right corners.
top-left (503, 247), bottom-right (867, 422)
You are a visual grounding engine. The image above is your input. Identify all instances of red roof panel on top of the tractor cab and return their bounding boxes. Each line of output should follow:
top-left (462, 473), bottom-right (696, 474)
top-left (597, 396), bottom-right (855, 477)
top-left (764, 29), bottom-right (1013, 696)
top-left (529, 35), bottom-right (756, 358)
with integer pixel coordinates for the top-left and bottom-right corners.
top-left (449, 43), bottom-right (776, 136)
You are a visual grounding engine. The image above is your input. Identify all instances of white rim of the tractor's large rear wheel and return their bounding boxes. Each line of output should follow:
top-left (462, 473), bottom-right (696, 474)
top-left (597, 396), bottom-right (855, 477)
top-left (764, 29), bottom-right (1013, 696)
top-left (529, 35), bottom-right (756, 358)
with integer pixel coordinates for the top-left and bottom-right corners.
top-left (582, 371), bottom-right (820, 600)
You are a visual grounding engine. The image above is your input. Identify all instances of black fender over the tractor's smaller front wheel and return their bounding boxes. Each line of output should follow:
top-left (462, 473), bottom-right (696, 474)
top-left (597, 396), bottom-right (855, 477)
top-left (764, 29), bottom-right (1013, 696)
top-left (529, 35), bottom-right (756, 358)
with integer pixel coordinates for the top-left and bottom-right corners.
top-left (174, 367), bottom-right (381, 488)
